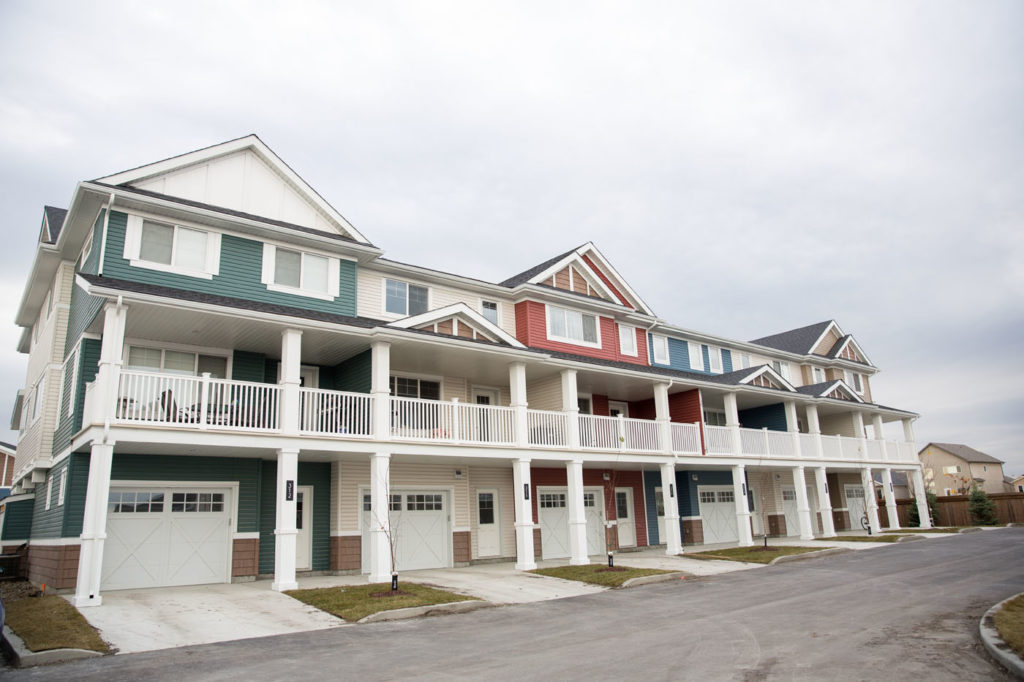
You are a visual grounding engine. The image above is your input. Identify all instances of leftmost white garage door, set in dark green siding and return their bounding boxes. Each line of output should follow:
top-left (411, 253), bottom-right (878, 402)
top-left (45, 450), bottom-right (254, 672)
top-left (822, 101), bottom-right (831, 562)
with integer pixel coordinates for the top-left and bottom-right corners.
top-left (100, 486), bottom-right (231, 590)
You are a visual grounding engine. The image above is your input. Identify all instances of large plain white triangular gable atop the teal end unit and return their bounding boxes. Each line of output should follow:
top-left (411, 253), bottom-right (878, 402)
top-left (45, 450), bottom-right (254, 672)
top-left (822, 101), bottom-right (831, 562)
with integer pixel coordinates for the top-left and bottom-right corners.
top-left (98, 135), bottom-right (368, 244)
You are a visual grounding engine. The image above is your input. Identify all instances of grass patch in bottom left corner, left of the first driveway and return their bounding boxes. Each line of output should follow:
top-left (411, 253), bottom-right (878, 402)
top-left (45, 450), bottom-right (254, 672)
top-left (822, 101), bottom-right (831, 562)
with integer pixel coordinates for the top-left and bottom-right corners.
top-left (4, 589), bottom-right (110, 653)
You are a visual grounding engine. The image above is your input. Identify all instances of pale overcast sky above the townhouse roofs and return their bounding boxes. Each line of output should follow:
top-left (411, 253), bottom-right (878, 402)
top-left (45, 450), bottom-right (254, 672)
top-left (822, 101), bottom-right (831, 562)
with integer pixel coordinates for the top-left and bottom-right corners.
top-left (0, 0), bottom-right (1024, 474)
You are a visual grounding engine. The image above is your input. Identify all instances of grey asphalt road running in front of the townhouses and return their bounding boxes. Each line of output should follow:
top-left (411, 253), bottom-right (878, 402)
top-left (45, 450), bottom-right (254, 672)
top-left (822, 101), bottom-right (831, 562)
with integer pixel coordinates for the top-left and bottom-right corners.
top-left (8, 528), bottom-right (1024, 680)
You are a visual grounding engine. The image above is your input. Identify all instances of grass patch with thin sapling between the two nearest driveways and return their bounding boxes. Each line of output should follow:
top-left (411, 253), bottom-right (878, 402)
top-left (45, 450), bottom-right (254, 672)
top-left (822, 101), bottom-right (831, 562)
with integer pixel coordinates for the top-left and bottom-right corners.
top-left (285, 583), bottom-right (476, 623)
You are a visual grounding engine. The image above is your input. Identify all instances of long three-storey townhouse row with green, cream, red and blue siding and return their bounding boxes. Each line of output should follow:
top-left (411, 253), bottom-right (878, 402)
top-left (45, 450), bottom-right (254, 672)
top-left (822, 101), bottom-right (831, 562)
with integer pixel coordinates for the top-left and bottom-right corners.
top-left (0, 135), bottom-right (927, 606)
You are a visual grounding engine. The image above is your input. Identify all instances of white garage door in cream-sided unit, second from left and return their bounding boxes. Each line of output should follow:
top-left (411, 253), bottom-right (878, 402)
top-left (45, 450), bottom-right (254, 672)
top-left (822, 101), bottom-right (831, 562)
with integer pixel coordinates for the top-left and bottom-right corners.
top-left (361, 491), bottom-right (452, 572)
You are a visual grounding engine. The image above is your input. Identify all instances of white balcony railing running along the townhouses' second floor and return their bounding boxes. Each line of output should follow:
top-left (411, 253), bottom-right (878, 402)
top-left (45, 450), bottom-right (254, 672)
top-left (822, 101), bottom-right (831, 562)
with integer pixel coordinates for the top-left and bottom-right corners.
top-left (94, 371), bottom-right (916, 464)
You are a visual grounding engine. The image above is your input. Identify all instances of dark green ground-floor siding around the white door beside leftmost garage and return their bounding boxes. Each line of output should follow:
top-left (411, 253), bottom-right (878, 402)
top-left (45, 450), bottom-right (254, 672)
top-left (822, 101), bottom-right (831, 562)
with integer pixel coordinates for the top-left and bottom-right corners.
top-left (259, 461), bottom-right (331, 574)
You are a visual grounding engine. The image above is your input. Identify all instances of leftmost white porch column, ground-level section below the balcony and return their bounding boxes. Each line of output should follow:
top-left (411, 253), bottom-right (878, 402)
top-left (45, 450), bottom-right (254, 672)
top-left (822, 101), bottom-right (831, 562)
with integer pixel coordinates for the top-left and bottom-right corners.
top-left (72, 440), bottom-right (114, 608)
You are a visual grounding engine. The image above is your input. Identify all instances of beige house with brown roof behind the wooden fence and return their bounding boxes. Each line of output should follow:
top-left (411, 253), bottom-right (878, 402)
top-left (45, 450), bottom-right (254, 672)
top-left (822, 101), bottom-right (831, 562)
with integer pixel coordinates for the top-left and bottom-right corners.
top-left (918, 442), bottom-right (1010, 495)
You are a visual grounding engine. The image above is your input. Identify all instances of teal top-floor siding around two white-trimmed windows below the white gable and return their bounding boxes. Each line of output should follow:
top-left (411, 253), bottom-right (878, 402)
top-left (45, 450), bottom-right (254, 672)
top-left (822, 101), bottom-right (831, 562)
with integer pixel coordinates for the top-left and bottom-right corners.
top-left (103, 211), bottom-right (356, 315)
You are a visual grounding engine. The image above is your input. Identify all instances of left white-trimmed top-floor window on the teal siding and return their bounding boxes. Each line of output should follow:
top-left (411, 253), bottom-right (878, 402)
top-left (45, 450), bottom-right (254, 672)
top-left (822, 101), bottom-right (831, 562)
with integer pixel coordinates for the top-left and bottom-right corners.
top-left (124, 215), bottom-right (220, 279)
